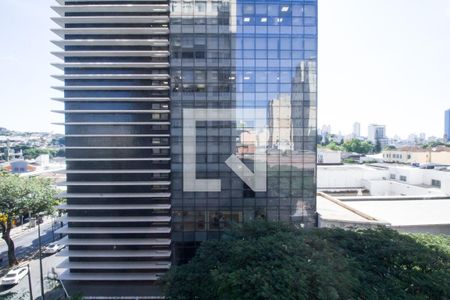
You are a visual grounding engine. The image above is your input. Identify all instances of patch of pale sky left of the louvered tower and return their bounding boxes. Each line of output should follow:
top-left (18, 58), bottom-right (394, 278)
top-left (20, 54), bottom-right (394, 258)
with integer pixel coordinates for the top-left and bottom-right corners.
top-left (0, 0), bottom-right (59, 132)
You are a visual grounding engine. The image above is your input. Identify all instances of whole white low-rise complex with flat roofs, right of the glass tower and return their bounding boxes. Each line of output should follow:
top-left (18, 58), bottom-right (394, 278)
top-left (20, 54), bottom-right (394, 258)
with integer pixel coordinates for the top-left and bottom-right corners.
top-left (317, 164), bottom-right (450, 234)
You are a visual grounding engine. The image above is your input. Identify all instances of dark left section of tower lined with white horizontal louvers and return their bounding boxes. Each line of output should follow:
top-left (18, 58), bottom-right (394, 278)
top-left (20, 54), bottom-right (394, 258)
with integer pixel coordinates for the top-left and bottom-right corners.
top-left (53, 0), bottom-right (171, 295)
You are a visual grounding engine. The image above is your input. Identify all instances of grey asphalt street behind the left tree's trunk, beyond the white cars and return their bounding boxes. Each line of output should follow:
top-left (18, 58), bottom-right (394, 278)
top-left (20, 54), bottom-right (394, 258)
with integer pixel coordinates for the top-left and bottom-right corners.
top-left (0, 222), bottom-right (59, 274)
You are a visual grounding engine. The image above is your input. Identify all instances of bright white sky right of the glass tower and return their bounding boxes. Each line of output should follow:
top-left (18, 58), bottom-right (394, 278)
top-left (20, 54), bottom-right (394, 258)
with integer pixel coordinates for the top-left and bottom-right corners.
top-left (318, 0), bottom-right (450, 138)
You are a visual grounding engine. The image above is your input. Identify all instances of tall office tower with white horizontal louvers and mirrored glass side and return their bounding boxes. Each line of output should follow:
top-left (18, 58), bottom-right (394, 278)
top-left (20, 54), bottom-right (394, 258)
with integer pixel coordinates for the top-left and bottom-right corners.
top-left (54, 0), bottom-right (317, 296)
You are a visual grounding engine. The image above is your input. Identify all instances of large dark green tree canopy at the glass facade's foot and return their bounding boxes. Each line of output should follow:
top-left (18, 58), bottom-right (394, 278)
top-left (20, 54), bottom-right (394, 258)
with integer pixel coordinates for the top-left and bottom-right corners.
top-left (163, 222), bottom-right (450, 300)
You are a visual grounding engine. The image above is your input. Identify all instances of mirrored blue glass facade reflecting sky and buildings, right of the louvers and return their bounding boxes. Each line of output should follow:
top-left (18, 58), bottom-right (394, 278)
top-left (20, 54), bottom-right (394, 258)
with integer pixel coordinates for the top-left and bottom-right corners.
top-left (170, 0), bottom-right (317, 261)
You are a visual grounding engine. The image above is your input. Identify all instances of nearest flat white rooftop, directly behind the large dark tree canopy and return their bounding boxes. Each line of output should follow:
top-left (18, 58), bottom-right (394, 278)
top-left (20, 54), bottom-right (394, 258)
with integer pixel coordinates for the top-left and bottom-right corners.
top-left (317, 191), bottom-right (450, 235)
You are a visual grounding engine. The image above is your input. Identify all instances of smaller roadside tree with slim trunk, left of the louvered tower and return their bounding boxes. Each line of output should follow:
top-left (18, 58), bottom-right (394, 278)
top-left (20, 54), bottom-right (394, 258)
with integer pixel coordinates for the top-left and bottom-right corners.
top-left (0, 173), bottom-right (58, 265)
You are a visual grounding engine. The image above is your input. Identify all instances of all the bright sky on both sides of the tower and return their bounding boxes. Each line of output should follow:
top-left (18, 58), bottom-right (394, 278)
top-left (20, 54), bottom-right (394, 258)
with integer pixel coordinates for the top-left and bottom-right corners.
top-left (0, 0), bottom-right (450, 137)
